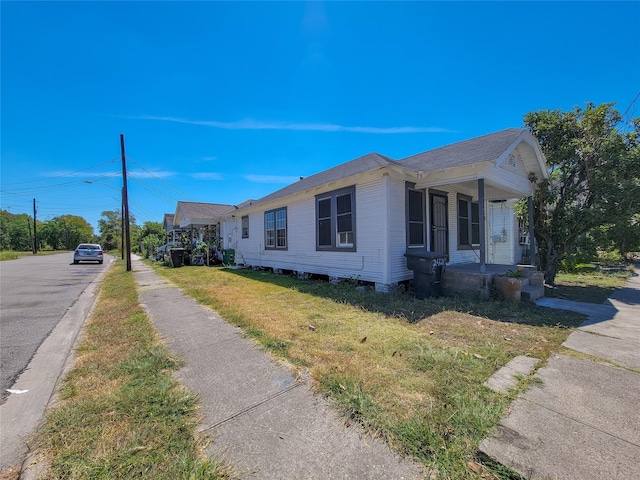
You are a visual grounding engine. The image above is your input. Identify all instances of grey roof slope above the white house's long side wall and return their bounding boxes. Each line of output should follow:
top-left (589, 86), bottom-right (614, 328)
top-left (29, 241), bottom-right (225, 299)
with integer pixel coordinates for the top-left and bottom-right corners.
top-left (248, 153), bottom-right (398, 206)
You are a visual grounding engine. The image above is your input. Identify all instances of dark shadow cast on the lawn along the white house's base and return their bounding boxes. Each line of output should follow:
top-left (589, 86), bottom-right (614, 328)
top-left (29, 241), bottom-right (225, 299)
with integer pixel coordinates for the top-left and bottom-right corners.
top-left (225, 269), bottom-right (586, 328)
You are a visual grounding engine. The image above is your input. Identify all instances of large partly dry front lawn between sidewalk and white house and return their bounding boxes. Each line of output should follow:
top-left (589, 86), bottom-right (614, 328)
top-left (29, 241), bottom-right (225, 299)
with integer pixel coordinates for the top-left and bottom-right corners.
top-left (155, 265), bottom-right (584, 479)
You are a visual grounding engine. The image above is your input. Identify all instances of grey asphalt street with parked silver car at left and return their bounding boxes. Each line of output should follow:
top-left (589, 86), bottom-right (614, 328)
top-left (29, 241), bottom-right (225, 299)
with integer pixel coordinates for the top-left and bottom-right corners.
top-left (0, 252), bottom-right (107, 403)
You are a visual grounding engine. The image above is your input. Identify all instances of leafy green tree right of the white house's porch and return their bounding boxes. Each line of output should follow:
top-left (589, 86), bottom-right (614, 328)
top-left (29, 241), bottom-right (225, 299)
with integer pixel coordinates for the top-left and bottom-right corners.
top-left (524, 103), bottom-right (640, 285)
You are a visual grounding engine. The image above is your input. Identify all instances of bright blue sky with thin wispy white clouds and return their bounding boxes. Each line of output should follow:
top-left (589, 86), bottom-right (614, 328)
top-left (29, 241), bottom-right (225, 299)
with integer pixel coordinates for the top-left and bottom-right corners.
top-left (0, 1), bottom-right (640, 233)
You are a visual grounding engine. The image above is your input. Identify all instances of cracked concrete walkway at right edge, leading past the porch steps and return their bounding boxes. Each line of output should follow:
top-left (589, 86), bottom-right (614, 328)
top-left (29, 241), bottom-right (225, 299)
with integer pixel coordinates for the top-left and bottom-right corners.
top-left (480, 270), bottom-right (640, 480)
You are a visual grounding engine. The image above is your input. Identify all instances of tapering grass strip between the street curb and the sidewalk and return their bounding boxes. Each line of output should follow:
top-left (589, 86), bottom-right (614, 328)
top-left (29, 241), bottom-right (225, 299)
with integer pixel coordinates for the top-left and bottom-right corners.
top-left (36, 260), bottom-right (231, 479)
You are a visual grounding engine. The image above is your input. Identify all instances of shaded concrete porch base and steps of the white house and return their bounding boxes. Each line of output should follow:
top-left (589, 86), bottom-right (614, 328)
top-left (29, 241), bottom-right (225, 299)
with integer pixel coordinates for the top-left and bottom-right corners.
top-left (441, 263), bottom-right (544, 301)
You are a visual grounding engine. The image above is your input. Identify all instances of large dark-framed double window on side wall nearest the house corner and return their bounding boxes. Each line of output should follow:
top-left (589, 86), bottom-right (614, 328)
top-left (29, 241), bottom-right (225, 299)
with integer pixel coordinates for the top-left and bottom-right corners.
top-left (316, 187), bottom-right (356, 252)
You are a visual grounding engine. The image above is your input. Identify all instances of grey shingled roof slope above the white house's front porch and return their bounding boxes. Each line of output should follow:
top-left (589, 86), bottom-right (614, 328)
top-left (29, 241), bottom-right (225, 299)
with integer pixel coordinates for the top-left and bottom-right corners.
top-left (399, 128), bottom-right (528, 172)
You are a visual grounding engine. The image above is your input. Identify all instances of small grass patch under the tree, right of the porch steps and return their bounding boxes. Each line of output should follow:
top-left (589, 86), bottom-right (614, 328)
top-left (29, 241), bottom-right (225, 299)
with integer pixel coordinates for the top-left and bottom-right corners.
top-left (545, 264), bottom-right (631, 303)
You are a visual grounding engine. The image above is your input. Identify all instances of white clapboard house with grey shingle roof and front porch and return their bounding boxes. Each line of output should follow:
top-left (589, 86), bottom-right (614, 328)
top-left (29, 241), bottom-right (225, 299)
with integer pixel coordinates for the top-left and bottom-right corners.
top-left (219, 129), bottom-right (548, 291)
